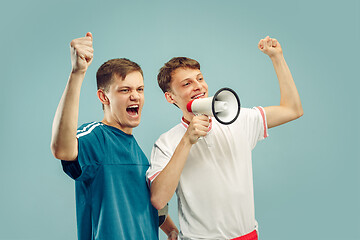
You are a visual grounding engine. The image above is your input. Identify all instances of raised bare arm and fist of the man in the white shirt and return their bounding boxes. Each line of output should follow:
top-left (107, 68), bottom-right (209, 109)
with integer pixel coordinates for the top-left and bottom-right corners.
top-left (258, 36), bottom-right (303, 128)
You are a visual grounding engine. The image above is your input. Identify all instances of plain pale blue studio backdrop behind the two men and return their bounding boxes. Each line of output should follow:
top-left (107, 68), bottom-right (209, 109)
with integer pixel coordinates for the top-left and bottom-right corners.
top-left (0, 0), bottom-right (360, 240)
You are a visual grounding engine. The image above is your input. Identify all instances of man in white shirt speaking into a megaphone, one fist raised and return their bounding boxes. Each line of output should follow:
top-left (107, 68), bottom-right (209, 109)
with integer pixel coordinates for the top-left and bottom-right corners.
top-left (147, 37), bottom-right (303, 240)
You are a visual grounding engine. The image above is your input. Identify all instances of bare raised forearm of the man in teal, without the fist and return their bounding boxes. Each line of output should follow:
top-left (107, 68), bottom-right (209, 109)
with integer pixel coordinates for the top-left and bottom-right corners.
top-left (51, 72), bottom-right (85, 160)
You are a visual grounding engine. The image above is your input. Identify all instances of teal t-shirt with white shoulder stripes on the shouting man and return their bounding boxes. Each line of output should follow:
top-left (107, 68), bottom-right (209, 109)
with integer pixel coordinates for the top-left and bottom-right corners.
top-left (62, 122), bottom-right (158, 240)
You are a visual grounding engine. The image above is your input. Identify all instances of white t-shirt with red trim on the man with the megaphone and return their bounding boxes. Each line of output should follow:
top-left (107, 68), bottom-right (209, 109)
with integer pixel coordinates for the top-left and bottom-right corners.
top-left (147, 107), bottom-right (268, 239)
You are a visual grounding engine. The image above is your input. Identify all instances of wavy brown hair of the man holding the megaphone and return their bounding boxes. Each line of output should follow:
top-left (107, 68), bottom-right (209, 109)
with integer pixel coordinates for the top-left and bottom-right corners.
top-left (158, 57), bottom-right (200, 93)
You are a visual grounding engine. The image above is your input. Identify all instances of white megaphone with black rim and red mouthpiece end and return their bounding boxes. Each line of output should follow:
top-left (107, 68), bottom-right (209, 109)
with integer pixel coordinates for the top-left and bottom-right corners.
top-left (186, 88), bottom-right (241, 125)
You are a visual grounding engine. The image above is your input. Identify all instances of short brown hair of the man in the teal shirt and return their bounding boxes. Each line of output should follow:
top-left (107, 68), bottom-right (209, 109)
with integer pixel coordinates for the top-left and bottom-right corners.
top-left (96, 58), bottom-right (144, 92)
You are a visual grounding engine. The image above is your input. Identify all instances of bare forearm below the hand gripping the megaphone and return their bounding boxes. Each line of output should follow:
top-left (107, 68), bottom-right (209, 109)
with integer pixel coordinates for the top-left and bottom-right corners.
top-left (151, 137), bottom-right (191, 209)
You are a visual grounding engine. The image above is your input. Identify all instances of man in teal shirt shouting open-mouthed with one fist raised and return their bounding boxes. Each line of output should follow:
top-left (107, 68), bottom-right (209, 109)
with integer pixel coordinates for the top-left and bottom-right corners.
top-left (51, 33), bottom-right (177, 240)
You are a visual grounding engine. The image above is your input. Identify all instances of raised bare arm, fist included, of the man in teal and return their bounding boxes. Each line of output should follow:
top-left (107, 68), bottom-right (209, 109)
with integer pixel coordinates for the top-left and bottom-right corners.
top-left (51, 33), bottom-right (93, 161)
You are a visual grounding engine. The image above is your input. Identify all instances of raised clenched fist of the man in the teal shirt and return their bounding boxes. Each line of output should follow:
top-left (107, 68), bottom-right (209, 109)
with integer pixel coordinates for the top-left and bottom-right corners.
top-left (70, 32), bottom-right (94, 72)
